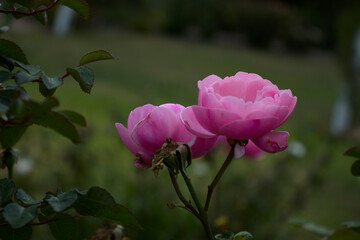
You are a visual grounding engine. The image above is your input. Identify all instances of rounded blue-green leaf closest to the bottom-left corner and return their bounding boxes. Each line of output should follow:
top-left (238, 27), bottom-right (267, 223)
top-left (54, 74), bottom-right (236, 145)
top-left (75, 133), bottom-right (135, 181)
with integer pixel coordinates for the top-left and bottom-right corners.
top-left (3, 203), bottom-right (37, 228)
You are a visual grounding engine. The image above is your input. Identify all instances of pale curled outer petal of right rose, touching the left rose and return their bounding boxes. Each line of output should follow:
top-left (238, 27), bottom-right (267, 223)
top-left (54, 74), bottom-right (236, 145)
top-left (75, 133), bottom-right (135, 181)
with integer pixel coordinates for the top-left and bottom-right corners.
top-left (180, 107), bottom-right (216, 138)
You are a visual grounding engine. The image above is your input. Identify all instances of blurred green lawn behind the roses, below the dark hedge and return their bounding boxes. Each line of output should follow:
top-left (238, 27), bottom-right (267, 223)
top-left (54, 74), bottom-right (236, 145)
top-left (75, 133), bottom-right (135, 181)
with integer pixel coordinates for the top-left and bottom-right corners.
top-left (2, 28), bottom-right (360, 239)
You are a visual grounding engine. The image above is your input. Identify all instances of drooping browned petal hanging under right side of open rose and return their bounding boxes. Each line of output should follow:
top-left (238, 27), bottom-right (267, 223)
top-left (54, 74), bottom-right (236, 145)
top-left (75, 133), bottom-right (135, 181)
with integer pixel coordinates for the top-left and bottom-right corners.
top-left (252, 131), bottom-right (289, 153)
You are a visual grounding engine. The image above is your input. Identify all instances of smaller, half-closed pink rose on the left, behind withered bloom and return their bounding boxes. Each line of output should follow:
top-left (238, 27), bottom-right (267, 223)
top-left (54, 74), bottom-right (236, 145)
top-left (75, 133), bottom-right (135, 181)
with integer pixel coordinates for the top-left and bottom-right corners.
top-left (115, 103), bottom-right (217, 168)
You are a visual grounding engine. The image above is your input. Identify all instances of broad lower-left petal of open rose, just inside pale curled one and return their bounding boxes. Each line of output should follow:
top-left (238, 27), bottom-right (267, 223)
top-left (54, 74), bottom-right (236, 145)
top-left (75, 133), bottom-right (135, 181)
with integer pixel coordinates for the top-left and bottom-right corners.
top-left (191, 106), bottom-right (241, 135)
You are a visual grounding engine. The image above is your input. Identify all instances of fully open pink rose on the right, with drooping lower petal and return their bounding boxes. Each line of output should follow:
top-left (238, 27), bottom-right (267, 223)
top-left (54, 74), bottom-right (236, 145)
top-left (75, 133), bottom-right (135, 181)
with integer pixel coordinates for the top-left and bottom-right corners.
top-left (181, 72), bottom-right (297, 156)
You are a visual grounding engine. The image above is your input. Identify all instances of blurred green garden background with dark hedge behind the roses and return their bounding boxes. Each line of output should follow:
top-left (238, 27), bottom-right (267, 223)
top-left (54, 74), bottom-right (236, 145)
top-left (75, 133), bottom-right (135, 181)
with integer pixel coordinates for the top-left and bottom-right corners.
top-left (1, 0), bottom-right (360, 240)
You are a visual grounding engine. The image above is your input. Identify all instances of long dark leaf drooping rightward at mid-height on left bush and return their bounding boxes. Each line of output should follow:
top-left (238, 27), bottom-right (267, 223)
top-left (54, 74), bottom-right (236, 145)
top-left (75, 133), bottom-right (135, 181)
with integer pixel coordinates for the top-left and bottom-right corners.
top-left (33, 111), bottom-right (80, 143)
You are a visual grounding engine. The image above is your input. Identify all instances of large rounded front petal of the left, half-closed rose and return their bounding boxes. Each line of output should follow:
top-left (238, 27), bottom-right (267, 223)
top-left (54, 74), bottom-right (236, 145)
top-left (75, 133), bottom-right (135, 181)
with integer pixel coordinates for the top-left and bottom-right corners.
top-left (131, 107), bottom-right (179, 151)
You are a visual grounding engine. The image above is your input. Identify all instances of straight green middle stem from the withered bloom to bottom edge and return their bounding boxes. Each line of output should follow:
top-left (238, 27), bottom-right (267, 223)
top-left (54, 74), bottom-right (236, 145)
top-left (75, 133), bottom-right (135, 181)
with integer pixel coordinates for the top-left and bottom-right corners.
top-left (180, 169), bottom-right (215, 240)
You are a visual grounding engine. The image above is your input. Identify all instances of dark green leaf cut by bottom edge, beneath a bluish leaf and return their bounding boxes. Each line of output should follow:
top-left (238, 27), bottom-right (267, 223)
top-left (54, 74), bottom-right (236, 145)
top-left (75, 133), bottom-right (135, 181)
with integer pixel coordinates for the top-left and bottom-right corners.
top-left (49, 213), bottom-right (78, 240)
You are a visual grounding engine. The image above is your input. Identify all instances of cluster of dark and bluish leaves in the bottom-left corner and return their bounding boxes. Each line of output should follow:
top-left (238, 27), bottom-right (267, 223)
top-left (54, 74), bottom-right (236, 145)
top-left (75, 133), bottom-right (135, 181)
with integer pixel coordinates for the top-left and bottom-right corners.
top-left (0, 178), bottom-right (141, 240)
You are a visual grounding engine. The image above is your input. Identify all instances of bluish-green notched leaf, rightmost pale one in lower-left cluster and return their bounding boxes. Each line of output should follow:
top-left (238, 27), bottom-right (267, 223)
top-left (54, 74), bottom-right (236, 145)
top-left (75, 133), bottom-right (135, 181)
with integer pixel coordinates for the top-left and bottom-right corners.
top-left (45, 190), bottom-right (78, 212)
